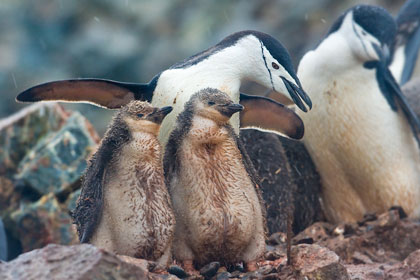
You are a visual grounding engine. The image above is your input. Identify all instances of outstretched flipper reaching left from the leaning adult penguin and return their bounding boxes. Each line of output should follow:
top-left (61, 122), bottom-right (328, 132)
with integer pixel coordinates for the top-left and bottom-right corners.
top-left (16, 79), bottom-right (153, 109)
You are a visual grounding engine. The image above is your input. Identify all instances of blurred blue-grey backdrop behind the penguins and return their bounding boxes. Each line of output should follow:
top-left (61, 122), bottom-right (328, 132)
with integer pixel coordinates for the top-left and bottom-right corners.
top-left (0, 0), bottom-right (404, 135)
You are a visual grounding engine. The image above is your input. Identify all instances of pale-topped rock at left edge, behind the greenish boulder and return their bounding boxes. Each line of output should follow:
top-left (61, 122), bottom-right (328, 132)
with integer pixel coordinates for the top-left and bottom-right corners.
top-left (0, 103), bottom-right (69, 178)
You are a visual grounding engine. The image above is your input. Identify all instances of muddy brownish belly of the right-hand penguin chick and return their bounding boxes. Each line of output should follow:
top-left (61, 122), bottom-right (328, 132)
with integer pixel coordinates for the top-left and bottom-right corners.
top-left (172, 137), bottom-right (264, 264)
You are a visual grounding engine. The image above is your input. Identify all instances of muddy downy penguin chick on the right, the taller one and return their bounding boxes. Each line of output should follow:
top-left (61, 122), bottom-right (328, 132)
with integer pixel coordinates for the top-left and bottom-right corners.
top-left (164, 88), bottom-right (265, 271)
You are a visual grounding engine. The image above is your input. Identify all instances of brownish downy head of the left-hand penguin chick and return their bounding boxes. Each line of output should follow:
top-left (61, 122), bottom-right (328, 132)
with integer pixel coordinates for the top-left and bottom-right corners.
top-left (120, 100), bottom-right (172, 135)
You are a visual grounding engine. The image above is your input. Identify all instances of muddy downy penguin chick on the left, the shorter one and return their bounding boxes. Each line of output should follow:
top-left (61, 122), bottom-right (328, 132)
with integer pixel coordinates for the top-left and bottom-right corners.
top-left (73, 101), bottom-right (175, 266)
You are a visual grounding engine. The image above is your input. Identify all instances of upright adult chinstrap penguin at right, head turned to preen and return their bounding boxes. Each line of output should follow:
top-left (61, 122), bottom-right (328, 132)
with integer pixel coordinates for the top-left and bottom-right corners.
top-left (298, 5), bottom-right (420, 222)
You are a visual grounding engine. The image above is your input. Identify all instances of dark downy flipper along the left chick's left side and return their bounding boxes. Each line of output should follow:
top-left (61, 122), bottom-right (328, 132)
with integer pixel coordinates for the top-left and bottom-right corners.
top-left (72, 117), bottom-right (129, 243)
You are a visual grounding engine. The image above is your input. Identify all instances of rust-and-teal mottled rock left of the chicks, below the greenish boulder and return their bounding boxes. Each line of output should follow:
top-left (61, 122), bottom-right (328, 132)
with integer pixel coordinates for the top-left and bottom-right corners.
top-left (8, 193), bottom-right (78, 252)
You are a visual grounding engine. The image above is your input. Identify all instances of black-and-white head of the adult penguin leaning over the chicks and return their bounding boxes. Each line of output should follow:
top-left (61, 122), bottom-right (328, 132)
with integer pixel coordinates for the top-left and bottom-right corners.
top-left (230, 30), bottom-right (312, 112)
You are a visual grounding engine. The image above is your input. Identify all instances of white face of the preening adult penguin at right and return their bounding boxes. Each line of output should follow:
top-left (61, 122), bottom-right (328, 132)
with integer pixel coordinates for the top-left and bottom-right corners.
top-left (338, 12), bottom-right (381, 62)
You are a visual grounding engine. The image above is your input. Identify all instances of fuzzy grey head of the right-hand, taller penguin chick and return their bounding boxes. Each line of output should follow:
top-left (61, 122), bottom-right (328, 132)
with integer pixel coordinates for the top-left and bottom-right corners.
top-left (190, 88), bottom-right (244, 124)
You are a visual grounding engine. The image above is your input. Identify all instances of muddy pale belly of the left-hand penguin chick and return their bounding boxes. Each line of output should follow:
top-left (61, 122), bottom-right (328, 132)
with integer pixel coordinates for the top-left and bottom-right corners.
top-left (91, 140), bottom-right (175, 260)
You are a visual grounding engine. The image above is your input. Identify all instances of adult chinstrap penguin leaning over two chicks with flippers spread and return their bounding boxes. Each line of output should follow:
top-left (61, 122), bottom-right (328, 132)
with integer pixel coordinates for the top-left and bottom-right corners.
top-left (16, 30), bottom-right (312, 145)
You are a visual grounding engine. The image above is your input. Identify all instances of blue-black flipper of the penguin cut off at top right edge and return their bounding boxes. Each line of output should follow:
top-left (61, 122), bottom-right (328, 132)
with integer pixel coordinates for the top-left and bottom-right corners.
top-left (396, 0), bottom-right (420, 85)
